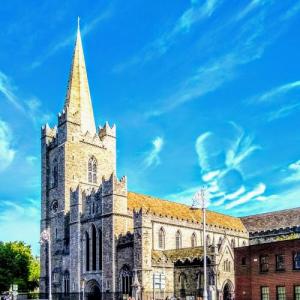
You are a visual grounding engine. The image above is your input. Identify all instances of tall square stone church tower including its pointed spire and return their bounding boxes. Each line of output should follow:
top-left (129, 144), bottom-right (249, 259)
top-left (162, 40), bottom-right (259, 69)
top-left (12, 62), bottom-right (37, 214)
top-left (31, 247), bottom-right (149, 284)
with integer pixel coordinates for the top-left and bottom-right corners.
top-left (40, 24), bottom-right (116, 293)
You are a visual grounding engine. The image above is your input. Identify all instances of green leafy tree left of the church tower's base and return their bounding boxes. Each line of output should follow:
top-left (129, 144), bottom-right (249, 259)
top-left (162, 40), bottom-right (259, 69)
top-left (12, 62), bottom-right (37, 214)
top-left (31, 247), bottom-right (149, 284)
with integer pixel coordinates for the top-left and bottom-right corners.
top-left (0, 242), bottom-right (40, 292)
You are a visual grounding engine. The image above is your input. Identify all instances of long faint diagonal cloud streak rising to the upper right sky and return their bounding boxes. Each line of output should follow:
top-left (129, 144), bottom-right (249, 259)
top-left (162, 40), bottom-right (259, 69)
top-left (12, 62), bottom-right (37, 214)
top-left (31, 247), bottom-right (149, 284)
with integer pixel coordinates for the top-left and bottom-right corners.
top-left (147, 1), bottom-right (297, 117)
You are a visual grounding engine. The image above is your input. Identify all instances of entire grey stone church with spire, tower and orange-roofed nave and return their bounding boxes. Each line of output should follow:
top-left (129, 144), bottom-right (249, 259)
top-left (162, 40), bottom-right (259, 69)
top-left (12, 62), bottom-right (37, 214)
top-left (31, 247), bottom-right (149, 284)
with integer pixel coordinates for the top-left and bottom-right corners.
top-left (40, 24), bottom-right (249, 299)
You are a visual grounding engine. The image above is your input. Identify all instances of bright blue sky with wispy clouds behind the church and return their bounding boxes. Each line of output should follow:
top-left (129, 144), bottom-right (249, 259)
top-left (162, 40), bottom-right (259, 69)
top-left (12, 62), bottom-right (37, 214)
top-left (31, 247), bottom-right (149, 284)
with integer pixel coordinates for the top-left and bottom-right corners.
top-left (0, 0), bottom-right (300, 253)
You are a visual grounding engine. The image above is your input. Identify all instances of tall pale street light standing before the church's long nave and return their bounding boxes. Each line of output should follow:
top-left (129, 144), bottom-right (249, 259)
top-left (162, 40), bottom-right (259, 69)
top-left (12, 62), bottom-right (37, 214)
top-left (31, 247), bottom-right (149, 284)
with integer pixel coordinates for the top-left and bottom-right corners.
top-left (192, 187), bottom-right (209, 300)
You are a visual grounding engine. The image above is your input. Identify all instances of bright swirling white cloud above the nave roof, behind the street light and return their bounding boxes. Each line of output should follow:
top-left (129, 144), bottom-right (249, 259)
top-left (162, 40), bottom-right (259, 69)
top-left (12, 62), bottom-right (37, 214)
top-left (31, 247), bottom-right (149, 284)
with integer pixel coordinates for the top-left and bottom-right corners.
top-left (166, 122), bottom-right (270, 210)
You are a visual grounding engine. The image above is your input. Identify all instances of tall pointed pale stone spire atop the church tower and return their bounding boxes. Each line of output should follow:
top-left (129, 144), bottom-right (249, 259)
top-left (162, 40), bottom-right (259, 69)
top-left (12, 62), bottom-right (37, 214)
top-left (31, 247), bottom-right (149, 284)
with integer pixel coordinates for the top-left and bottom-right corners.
top-left (65, 17), bottom-right (96, 134)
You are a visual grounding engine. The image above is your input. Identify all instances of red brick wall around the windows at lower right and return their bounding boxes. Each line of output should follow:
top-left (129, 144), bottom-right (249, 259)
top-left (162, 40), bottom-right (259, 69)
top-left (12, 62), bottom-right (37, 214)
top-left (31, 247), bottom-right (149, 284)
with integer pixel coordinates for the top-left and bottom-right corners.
top-left (234, 239), bottom-right (300, 300)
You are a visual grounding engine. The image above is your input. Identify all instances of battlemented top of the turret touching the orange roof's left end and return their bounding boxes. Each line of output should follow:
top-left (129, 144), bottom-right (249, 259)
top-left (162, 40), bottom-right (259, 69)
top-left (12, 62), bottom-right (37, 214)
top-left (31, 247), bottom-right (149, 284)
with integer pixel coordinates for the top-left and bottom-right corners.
top-left (102, 172), bottom-right (127, 197)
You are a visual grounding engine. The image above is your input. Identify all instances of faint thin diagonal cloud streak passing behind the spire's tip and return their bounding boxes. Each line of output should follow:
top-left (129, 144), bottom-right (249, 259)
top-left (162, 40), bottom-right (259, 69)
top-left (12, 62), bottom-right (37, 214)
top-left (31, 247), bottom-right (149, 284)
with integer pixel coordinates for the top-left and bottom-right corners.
top-left (31, 5), bottom-right (113, 69)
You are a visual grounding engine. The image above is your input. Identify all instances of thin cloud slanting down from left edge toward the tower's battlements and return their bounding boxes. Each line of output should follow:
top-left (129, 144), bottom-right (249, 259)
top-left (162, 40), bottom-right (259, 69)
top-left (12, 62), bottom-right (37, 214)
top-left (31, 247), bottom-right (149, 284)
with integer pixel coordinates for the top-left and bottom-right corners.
top-left (0, 71), bottom-right (52, 124)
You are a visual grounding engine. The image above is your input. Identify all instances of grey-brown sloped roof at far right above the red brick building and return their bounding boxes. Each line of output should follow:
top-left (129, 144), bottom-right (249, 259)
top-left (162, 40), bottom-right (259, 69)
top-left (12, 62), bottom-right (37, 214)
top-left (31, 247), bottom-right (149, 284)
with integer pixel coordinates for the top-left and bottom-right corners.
top-left (241, 207), bottom-right (300, 232)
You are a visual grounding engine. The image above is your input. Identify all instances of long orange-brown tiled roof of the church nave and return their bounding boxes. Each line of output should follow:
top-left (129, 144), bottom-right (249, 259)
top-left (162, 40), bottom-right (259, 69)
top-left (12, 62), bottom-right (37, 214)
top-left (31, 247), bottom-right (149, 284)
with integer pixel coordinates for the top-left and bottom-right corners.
top-left (128, 192), bottom-right (246, 232)
